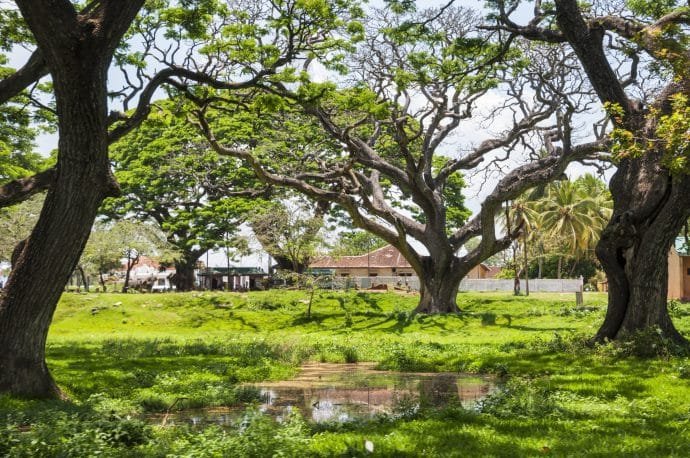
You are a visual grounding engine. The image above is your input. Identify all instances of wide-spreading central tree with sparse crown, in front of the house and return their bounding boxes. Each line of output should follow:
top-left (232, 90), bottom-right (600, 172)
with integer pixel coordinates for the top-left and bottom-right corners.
top-left (191, 7), bottom-right (601, 313)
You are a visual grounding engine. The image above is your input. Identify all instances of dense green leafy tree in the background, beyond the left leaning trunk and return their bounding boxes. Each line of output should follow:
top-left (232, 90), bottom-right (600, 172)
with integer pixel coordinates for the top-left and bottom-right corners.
top-left (105, 103), bottom-right (264, 291)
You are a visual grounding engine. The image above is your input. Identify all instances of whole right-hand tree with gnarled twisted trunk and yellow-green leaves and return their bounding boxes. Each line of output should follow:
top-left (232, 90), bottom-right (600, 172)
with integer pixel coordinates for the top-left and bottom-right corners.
top-left (492, 0), bottom-right (690, 342)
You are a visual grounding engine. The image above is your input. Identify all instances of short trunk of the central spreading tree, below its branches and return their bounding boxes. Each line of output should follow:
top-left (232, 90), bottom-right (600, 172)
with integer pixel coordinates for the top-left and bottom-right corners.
top-left (415, 256), bottom-right (463, 314)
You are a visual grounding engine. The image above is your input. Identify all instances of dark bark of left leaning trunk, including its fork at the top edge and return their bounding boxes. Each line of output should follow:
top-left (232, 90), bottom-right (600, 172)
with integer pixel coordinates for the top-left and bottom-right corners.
top-left (0, 0), bottom-right (142, 397)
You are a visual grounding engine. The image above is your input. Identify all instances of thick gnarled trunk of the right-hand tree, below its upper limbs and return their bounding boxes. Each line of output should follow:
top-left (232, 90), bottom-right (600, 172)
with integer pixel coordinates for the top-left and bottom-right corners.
top-left (595, 154), bottom-right (690, 343)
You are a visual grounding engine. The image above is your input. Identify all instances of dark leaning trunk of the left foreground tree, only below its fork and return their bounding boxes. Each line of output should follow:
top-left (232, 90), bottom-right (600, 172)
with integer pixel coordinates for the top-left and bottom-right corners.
top-left (0, 67), bottom-right (115, 398)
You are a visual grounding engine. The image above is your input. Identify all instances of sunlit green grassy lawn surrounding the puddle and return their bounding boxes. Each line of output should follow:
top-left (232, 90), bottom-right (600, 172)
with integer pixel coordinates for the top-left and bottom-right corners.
top-left (0, 291), bottom-right (690, 457)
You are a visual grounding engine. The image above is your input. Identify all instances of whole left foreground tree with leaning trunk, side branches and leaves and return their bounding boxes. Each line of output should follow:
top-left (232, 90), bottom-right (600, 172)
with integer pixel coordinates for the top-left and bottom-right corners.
top-left (0, 0), bottom-right (362, 397)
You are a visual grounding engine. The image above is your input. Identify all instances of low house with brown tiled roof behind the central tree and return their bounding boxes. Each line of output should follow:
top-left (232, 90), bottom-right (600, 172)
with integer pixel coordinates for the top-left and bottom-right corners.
top-left (309, 245), bottom-right (493, 278)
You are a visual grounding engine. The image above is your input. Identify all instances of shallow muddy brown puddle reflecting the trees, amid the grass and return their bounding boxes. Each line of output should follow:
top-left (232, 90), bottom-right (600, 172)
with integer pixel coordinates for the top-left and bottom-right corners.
top-left (151, 363), bottom-right (494, 426)
